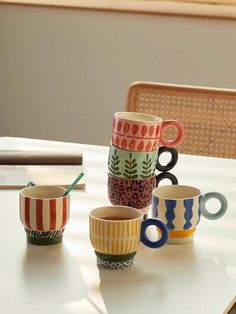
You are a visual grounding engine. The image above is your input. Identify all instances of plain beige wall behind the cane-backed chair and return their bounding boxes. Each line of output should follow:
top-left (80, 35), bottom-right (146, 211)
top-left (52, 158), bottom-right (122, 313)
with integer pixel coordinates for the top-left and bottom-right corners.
top-left (0, 5), bottom-right (236, 144)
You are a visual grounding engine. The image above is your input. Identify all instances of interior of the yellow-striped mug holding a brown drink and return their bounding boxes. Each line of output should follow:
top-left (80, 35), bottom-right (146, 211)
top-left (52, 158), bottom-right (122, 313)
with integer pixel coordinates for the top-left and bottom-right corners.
top-left (90, 205), bottom-right (143, 221)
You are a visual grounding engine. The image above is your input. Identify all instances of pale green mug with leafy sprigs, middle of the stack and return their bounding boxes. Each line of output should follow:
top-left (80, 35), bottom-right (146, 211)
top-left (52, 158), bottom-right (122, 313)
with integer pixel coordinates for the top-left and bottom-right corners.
top-left (108, 144), bottom-right (178, 179)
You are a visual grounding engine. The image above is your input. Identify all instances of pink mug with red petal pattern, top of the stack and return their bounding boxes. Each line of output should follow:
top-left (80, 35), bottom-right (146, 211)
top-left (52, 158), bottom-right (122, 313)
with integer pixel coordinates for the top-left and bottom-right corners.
top-left (112, 112), bottom-right (184, 152)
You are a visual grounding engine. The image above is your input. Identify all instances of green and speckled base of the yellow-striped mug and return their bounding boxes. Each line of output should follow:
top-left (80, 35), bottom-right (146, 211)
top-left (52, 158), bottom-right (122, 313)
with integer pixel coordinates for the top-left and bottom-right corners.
top-left (95, 251), bottom-right (136, 269)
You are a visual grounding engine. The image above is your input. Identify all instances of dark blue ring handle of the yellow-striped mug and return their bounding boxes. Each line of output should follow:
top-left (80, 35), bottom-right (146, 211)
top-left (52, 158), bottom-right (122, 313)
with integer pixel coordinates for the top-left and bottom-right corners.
top-left (140, 218), bottom-right (168, 249)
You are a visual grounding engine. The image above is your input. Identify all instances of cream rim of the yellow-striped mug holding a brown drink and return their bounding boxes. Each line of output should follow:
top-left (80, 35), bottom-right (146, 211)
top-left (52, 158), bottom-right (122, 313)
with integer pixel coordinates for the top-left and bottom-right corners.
top-left (89, 205), bottom-right (143, 222)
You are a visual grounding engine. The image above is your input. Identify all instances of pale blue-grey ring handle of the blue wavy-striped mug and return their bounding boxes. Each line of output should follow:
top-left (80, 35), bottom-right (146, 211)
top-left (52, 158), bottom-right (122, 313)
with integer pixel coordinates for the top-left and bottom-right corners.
top-left (201, 192), bottom-right (228, 220)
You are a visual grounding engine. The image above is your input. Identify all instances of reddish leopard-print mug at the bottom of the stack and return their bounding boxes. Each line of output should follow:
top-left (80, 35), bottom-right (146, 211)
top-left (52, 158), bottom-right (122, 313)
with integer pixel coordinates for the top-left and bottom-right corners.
top-left (107, 172), bottom-right (178, 214)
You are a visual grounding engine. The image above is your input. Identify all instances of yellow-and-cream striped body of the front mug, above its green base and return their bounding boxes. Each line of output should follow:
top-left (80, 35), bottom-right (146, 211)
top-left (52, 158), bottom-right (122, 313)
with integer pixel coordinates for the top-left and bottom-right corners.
top-left (89, 216), bottom-right (142, 254)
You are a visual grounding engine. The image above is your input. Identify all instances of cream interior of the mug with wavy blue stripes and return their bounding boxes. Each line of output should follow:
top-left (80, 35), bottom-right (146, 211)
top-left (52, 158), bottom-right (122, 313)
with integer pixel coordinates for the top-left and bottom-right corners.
top-left (152, 185), bottom-right (201, 200)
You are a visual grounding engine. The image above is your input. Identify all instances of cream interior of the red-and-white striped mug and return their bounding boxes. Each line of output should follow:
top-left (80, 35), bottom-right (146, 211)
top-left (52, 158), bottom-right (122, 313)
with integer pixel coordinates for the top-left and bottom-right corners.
top-left (20, 185), bottom-right (66, 199)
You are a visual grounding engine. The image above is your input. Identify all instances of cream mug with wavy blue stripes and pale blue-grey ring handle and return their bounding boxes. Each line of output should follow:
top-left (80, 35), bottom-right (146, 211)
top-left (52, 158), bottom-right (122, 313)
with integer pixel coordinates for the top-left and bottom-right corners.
top-left (152, 185), bottom-right (228, 244)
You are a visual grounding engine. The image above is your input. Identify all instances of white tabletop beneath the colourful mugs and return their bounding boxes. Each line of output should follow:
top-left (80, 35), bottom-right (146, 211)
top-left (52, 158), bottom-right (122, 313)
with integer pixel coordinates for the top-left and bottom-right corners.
top-left (0, 138), bottom-right (236, 314)
